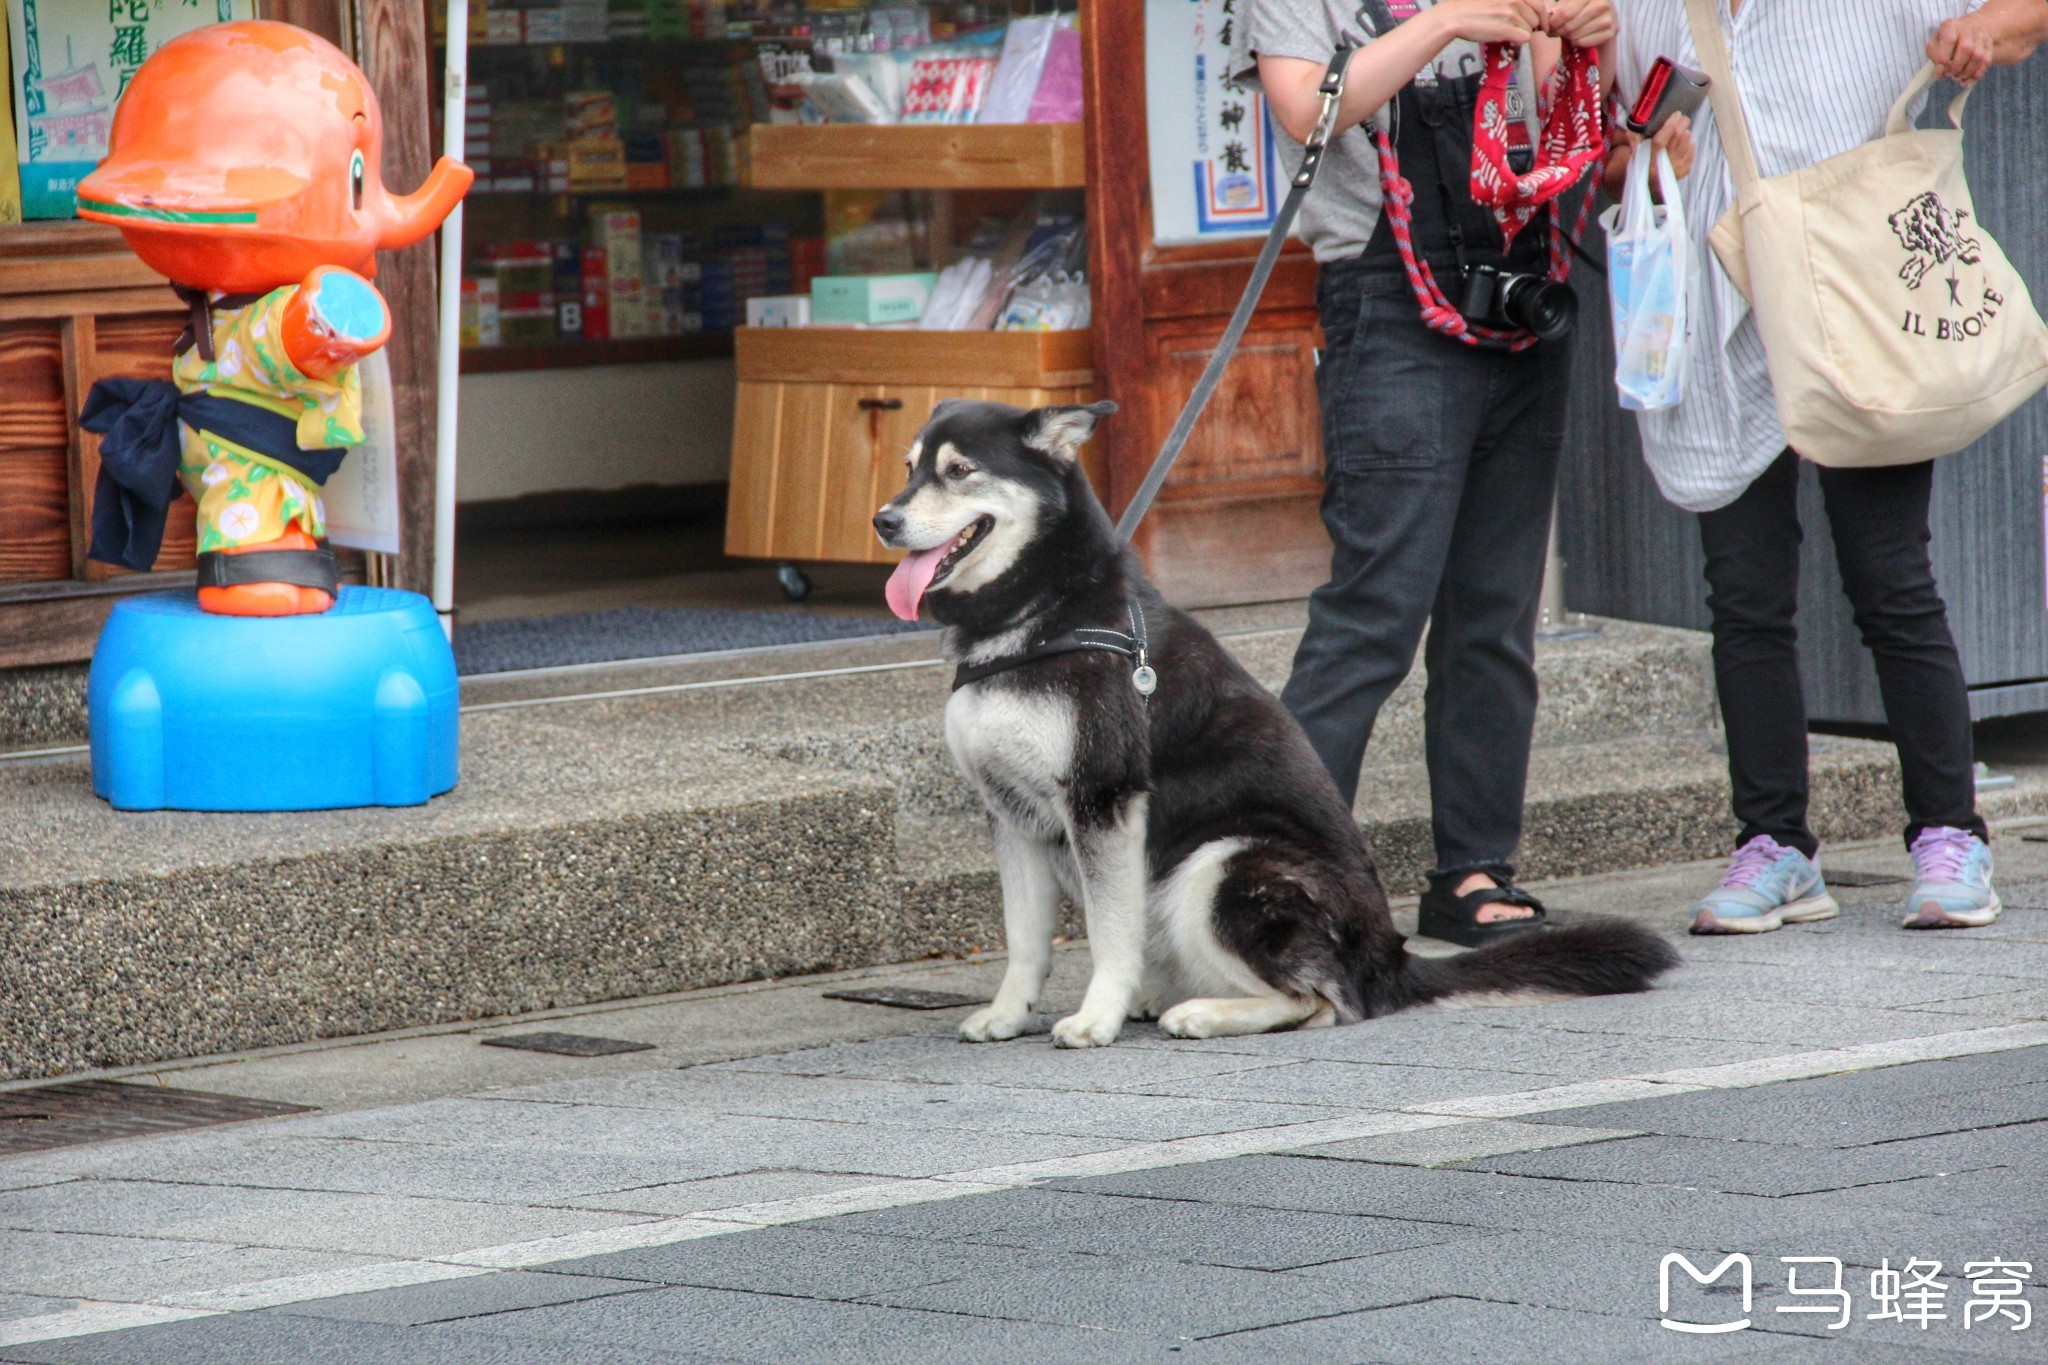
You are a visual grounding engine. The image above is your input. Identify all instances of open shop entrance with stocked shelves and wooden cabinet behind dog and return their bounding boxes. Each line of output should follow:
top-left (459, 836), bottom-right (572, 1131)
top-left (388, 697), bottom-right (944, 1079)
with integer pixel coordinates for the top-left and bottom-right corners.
top-left (436, 0), bottom-right (1094, 673)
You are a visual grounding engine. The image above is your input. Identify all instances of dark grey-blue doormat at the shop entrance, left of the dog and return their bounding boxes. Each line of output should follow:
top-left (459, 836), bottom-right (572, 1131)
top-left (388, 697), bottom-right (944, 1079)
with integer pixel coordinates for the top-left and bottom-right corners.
top-left (455, 606), bottom-right (934, 677)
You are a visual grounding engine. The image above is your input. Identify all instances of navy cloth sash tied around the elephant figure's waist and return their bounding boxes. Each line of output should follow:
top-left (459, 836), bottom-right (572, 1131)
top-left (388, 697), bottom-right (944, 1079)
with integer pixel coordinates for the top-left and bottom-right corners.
top-left (78, 379), bottom-right (348, 571)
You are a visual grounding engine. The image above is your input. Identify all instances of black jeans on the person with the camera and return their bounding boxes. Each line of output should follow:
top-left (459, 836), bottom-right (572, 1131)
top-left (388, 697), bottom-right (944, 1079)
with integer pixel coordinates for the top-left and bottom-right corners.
top-left (1280, 262), bottom-right (1571, 880)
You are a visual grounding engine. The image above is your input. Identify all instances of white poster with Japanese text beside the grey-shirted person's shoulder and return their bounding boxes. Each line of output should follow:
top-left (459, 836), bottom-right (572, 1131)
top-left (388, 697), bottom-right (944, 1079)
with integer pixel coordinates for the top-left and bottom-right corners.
top-left (1145, 0), bottom-right (1280, 246)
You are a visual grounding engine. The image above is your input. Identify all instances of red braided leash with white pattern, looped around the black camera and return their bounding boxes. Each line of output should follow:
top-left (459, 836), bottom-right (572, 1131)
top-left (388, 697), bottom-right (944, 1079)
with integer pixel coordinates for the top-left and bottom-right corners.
top-left (1372, 43), bottom-right (1608, 350)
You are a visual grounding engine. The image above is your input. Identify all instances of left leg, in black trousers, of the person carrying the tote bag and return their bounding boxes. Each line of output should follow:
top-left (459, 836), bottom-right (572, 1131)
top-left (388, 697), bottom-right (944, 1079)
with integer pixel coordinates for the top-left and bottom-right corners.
top-left (1700, 450), bottom-right (1821, 857)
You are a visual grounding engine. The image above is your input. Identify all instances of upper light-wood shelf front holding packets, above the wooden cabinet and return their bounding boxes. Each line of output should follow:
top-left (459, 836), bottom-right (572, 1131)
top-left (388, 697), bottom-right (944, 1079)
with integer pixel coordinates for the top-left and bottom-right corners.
top-left (748, 123), bottom-right (1085, 190)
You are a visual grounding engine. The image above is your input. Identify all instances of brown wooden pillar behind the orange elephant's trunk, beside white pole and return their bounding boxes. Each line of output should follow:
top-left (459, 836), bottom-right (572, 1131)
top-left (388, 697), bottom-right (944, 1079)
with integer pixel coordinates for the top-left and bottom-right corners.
top-left (356, 0), bottom-right (438, 591)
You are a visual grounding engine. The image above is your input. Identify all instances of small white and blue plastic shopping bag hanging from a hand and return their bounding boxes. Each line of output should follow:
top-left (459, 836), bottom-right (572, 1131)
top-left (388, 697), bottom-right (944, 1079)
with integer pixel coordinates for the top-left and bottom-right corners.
top-left (1599, 143), bottom-right (1692, 411)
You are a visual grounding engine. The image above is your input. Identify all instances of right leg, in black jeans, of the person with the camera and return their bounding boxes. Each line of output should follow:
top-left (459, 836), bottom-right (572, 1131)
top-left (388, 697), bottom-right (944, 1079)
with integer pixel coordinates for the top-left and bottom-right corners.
top-left (1423, 346), bottom-right (1571, 896)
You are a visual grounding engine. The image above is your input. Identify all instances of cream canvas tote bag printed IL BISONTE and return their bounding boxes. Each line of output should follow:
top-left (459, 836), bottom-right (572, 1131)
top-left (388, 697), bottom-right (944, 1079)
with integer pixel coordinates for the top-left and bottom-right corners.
top-left (1686, 0), bottom-right (2048, 467)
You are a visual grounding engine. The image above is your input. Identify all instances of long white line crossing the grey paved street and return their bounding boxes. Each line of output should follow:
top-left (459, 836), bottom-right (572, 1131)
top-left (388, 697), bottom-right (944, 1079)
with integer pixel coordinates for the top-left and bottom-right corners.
top-left (0, 1023), bottom-right (2048, 1347)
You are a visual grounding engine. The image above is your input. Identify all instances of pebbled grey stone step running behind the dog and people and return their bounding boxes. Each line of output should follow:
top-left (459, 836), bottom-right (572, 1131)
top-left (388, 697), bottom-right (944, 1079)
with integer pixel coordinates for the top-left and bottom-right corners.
top-left (0, 608), bottom-right (1949, 1078)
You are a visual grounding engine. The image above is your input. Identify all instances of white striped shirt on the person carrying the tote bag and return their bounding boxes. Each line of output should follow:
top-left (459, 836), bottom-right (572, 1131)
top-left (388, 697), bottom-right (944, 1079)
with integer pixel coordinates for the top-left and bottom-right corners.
top-left (1616, 0), bottom-right (1985, 512)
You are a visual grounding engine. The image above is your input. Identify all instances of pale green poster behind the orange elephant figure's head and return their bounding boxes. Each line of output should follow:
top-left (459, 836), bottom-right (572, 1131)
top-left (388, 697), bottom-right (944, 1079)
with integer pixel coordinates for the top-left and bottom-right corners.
top-left (6, 0), bottom-right (256, 219)
